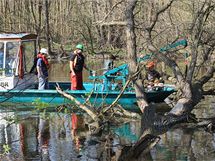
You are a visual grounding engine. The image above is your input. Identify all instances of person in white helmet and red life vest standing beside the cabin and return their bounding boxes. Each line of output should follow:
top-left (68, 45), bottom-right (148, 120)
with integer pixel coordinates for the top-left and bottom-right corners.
top-left (37, 48), bottom-right (49, 90)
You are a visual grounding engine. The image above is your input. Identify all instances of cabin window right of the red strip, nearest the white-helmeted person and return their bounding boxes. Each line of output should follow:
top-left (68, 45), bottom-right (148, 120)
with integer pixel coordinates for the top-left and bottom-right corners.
top-left (22, 41), bottom-right (36, 72)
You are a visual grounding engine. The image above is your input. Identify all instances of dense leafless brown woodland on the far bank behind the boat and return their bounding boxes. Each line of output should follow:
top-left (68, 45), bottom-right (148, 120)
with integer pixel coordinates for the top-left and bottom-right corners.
top-left (0, 0), bottom-right (202, 54)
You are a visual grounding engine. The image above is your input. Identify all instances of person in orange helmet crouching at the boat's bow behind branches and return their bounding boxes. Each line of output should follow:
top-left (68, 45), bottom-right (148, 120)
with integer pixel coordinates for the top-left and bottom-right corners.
top-left (146, 61), bottom-right (164, 90)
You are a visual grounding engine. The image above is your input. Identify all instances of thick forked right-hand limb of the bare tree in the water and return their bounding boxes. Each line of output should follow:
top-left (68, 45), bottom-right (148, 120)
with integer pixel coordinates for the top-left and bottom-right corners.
top-left (141, 1), bottom-right (214, 115)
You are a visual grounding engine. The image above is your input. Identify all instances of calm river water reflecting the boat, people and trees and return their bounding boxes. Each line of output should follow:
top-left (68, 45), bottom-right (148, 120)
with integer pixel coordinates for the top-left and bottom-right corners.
top-left (0, 60), bottom-right (215, 161)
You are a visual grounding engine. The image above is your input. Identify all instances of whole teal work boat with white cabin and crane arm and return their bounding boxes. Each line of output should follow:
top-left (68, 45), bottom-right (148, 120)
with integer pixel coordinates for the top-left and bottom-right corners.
top-left (0, 33), bottom-right (186, 108)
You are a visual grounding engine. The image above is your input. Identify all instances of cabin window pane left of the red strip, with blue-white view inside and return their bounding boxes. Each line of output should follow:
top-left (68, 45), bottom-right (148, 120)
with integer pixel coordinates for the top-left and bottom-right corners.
top-left (5, 42), bottom-right (19, 76)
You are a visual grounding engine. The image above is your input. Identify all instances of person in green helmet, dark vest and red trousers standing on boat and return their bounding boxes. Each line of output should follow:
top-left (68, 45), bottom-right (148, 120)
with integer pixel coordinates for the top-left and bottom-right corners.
top-left (70, 44), bottom-right (89, 90)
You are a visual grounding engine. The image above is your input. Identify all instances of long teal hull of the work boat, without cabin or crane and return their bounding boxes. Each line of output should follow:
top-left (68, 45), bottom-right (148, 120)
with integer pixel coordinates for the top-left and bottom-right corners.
top-left (0, 83), bottom-right (174, 110)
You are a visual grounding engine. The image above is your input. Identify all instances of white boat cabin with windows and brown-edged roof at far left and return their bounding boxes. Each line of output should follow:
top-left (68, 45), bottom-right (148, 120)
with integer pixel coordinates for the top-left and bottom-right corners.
top-left (0, 33), bottom-right (37, 90)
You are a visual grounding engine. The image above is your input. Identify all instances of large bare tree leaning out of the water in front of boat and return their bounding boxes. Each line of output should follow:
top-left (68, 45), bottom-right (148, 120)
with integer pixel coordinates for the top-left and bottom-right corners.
top-left (120, 0), bottom-right (215, 160)
